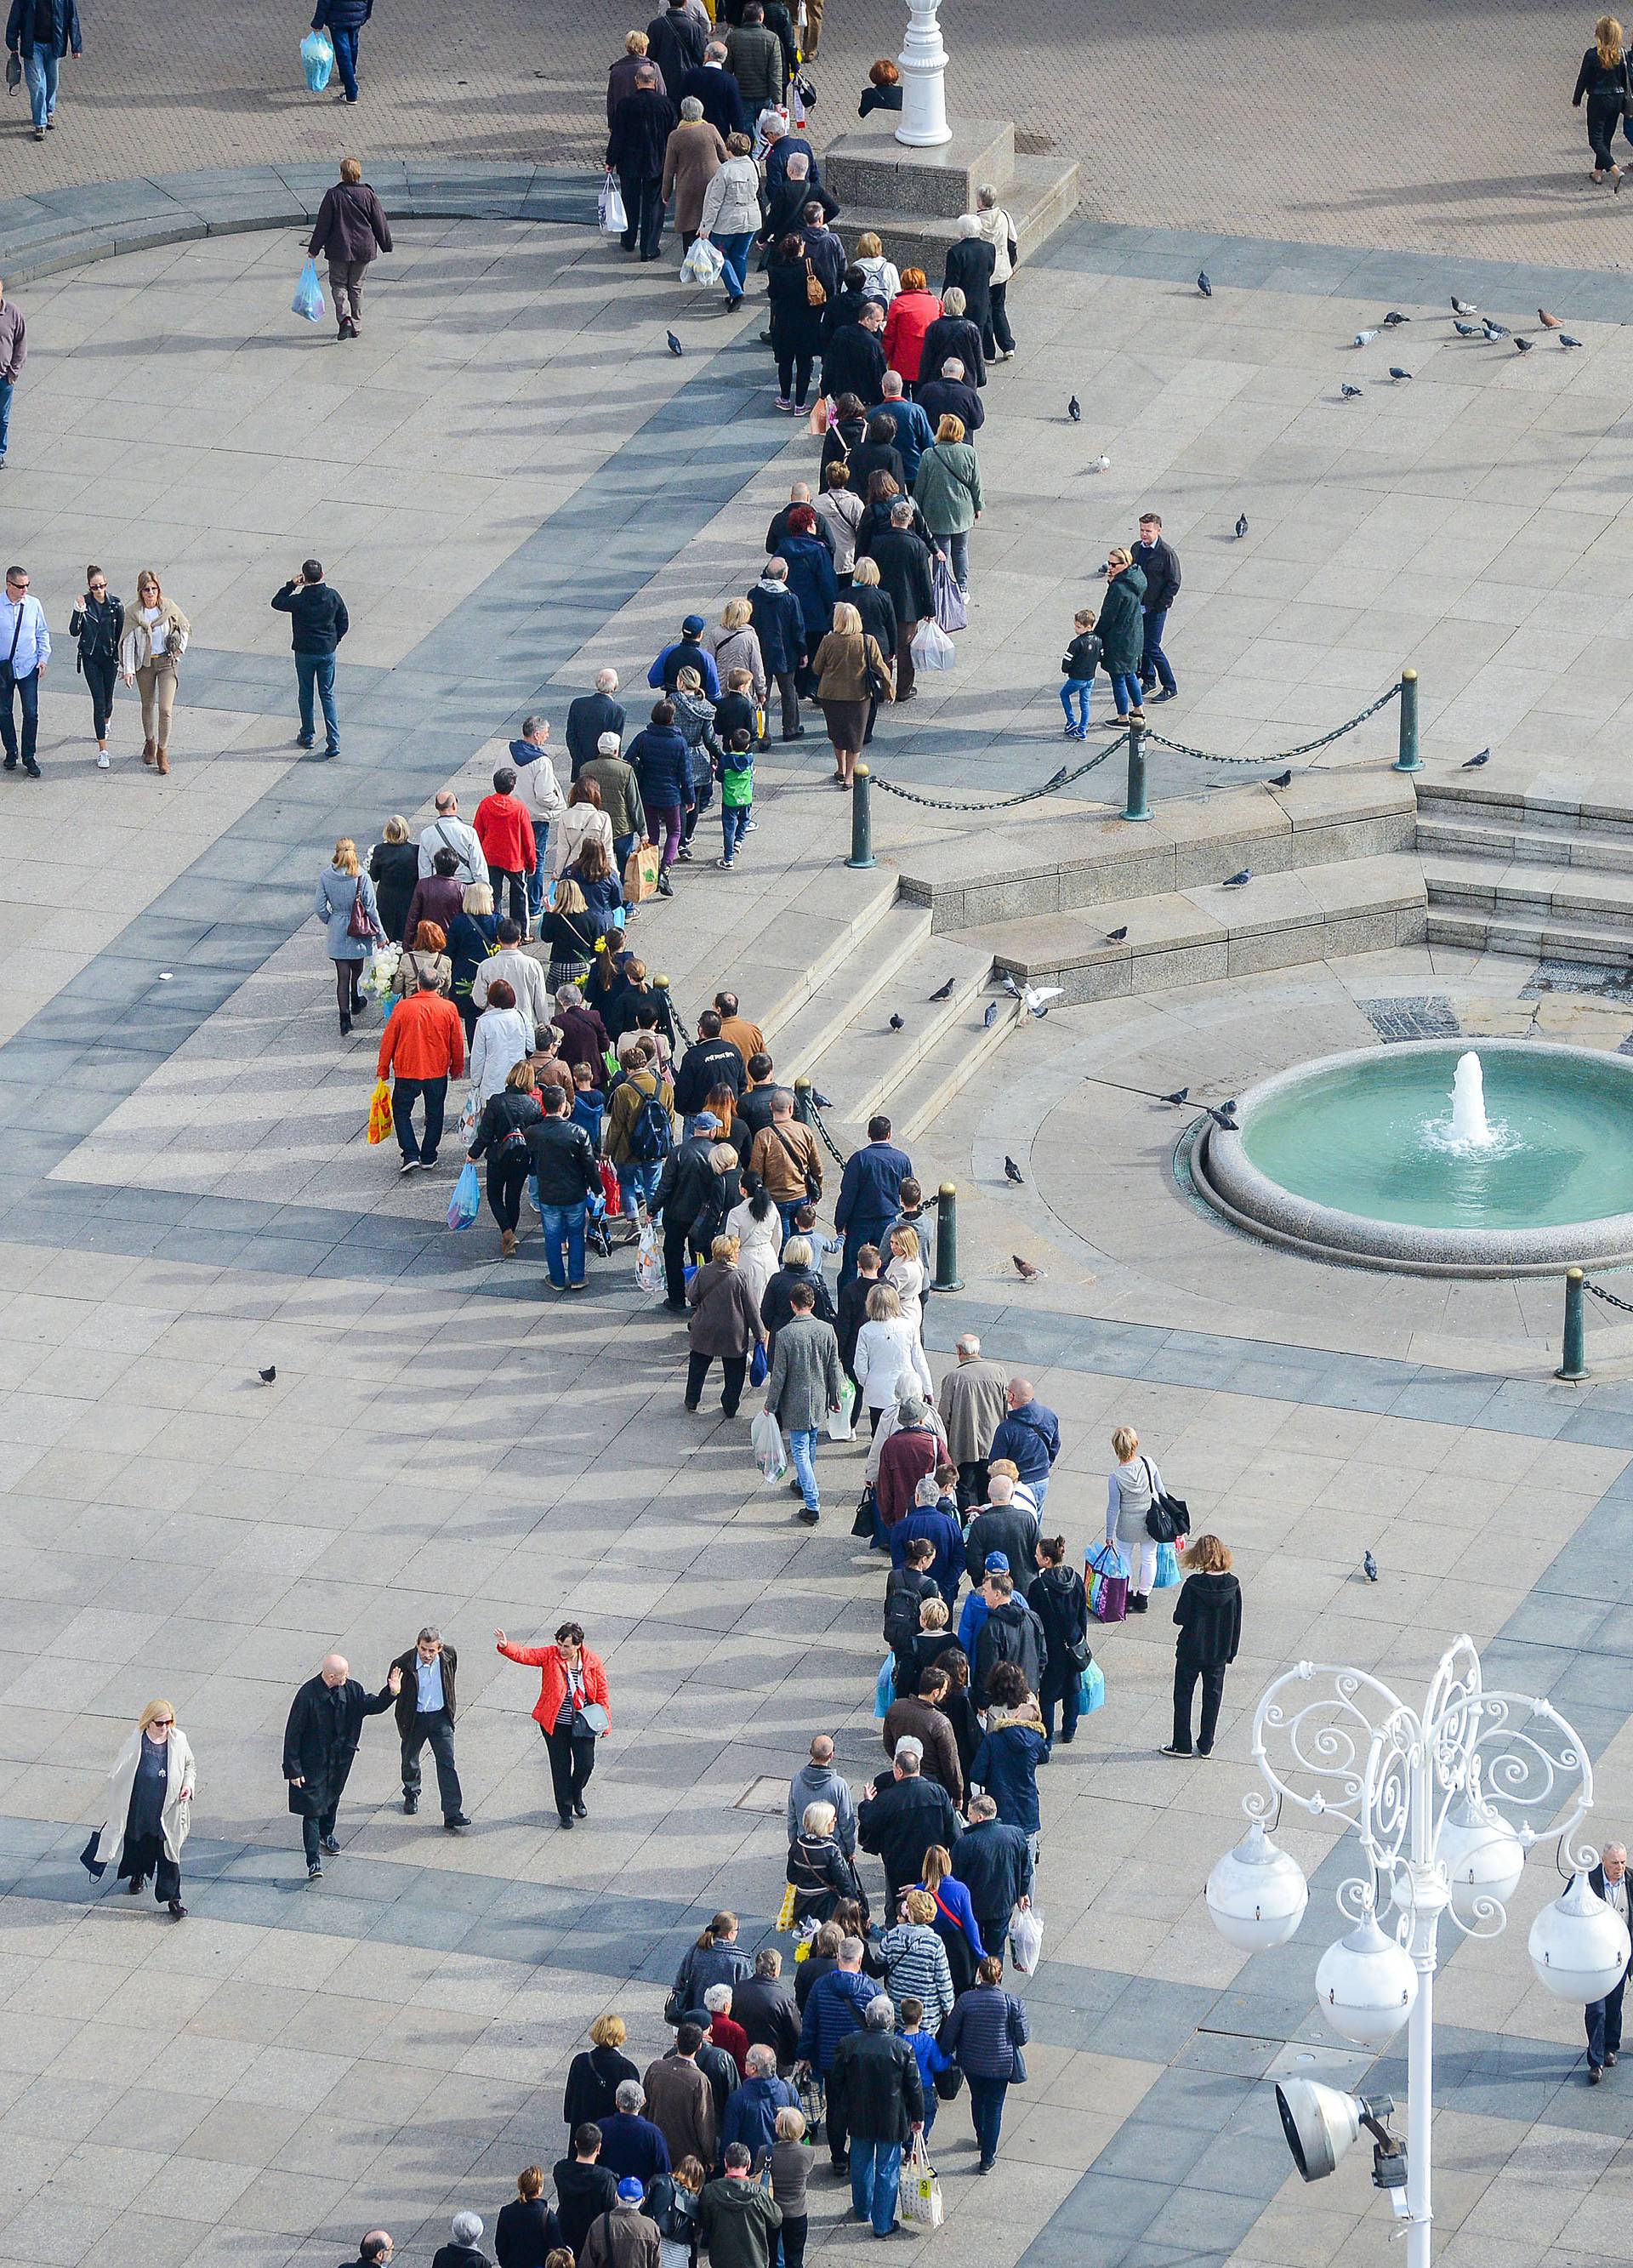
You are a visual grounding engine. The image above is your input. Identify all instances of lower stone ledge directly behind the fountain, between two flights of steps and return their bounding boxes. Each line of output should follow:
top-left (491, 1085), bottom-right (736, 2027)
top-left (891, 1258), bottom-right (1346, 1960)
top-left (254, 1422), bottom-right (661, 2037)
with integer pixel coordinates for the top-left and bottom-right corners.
top-left (966, 852), bottom-right (1425, 1002)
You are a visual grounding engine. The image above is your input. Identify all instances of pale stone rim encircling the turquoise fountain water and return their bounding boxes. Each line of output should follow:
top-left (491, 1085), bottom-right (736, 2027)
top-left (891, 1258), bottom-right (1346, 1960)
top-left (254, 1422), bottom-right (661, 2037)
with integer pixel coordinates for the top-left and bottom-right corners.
top-left (1191, 1036), bottom-right (1633, 1277)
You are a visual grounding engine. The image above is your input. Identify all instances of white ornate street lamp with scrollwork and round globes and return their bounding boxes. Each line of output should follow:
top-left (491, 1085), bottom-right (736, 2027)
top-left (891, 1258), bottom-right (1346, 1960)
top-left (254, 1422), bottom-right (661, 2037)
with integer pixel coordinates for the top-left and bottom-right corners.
top-left (1207, 1638), bottom-right (1629, 2268)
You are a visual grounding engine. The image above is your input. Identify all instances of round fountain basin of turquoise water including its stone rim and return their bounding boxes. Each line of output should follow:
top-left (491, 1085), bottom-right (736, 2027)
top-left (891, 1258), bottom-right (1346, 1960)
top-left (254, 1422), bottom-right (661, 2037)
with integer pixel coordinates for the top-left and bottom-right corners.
top-left (1191, 1039), bottom-right (1633, 1277)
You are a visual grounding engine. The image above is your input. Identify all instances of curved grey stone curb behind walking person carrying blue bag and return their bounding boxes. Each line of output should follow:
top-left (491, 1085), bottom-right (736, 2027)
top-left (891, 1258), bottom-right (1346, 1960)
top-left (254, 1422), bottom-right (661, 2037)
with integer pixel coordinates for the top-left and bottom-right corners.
top-left (0, 159), bottom-right (599, 286)
